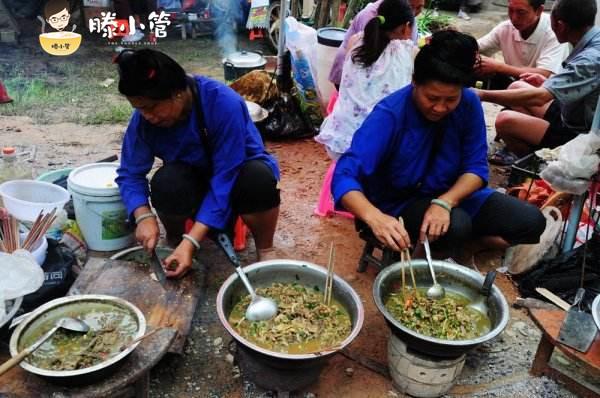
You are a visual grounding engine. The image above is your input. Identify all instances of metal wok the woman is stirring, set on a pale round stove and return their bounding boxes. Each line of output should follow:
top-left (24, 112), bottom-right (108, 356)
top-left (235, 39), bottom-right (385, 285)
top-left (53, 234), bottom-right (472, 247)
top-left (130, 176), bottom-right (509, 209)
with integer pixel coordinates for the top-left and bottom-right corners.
top-left (373, 260), bottom-right (509, 358)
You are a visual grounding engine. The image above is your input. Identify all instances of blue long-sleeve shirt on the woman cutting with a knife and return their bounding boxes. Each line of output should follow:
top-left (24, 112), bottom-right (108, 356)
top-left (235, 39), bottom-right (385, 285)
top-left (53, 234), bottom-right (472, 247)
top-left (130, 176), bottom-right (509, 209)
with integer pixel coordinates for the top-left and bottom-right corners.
top-left (116, 76), bottom-right (279, 229)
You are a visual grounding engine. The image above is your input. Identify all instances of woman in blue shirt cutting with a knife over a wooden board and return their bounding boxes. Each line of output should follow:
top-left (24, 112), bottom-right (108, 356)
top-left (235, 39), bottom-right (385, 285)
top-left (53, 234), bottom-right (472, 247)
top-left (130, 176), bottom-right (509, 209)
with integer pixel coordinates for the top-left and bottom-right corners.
top-left (115, 49), bottom-right (280, 277)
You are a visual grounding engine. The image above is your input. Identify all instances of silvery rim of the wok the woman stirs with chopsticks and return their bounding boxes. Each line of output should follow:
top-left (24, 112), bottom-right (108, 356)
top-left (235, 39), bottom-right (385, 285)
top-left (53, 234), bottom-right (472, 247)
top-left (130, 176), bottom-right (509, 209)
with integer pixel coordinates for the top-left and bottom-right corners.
top-left (373, 259), bottom-right (510, 348)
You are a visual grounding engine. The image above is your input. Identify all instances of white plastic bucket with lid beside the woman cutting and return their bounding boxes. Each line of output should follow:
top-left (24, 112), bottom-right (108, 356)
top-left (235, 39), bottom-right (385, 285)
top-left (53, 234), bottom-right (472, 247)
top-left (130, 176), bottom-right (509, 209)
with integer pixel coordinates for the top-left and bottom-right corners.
top-left (67, 163), bottom-right (133, 251)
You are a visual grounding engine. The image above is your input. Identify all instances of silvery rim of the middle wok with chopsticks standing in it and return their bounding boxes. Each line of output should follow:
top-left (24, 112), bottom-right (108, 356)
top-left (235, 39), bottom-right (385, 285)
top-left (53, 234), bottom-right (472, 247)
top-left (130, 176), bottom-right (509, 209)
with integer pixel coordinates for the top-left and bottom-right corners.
top-left (217, 259), bottom-right (365, 360)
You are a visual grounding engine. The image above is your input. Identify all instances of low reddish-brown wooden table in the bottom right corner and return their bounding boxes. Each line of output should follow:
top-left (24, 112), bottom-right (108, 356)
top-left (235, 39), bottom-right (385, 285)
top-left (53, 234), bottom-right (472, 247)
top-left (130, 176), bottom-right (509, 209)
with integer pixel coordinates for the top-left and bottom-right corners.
top-left (529, 308), bottom-right (600, 398)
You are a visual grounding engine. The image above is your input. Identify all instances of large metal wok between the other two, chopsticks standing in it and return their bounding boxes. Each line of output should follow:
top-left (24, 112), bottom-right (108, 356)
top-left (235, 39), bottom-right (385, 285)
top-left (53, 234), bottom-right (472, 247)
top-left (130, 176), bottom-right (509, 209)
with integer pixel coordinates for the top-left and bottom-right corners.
top-left (217, 260), bottom-right (364, 369)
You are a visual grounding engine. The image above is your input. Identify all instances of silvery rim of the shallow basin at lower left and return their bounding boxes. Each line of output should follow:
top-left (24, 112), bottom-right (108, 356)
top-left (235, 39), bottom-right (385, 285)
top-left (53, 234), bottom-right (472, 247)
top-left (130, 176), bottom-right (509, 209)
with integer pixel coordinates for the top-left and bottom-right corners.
top-left (10, 294), bottom-right (147, 378)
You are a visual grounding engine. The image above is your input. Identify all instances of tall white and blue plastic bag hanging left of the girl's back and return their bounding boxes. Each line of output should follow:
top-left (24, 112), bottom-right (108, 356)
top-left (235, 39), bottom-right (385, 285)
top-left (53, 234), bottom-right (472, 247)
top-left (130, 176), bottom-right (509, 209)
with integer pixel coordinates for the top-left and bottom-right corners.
top-left (285, 17), bottom-right (323, 127)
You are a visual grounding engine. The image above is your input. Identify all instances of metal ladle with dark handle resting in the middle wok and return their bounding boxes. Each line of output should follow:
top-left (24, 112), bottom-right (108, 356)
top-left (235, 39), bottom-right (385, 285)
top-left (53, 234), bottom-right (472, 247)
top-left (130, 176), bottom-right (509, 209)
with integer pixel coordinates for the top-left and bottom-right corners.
top-left (217, 233), bottom-right (277, 321)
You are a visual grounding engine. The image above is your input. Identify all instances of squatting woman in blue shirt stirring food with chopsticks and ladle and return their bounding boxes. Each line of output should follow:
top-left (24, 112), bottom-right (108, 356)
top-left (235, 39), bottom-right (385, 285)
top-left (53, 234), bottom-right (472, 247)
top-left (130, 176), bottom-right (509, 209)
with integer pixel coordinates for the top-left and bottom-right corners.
top-left (332, 31), bottom-right (545, 255)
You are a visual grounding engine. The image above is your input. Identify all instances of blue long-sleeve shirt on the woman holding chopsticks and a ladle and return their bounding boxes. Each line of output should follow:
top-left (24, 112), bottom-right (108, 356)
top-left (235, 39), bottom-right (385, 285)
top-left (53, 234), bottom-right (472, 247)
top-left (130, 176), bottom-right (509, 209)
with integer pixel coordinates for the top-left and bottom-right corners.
top-left (331, 85), bottom-right (493, 216)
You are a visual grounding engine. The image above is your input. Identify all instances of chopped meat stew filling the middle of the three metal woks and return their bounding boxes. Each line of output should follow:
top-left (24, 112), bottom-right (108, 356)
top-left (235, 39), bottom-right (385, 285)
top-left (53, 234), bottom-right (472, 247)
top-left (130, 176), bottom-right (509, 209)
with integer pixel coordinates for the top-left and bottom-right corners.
top-left (229, 283), bottom-right (352, 354)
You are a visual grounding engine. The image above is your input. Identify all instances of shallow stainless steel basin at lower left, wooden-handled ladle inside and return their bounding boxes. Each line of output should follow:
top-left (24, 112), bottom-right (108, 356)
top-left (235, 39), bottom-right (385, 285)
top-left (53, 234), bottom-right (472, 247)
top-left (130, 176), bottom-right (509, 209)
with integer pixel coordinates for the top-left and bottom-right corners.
top-left (10, 294), bottom-right (146, 384)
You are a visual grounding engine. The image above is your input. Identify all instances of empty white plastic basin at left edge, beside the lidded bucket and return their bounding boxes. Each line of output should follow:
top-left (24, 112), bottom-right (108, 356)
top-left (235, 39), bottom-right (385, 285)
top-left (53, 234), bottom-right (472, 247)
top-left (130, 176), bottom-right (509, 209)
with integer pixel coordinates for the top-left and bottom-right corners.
top-left (0, 180), bottom-right (71, 221)
